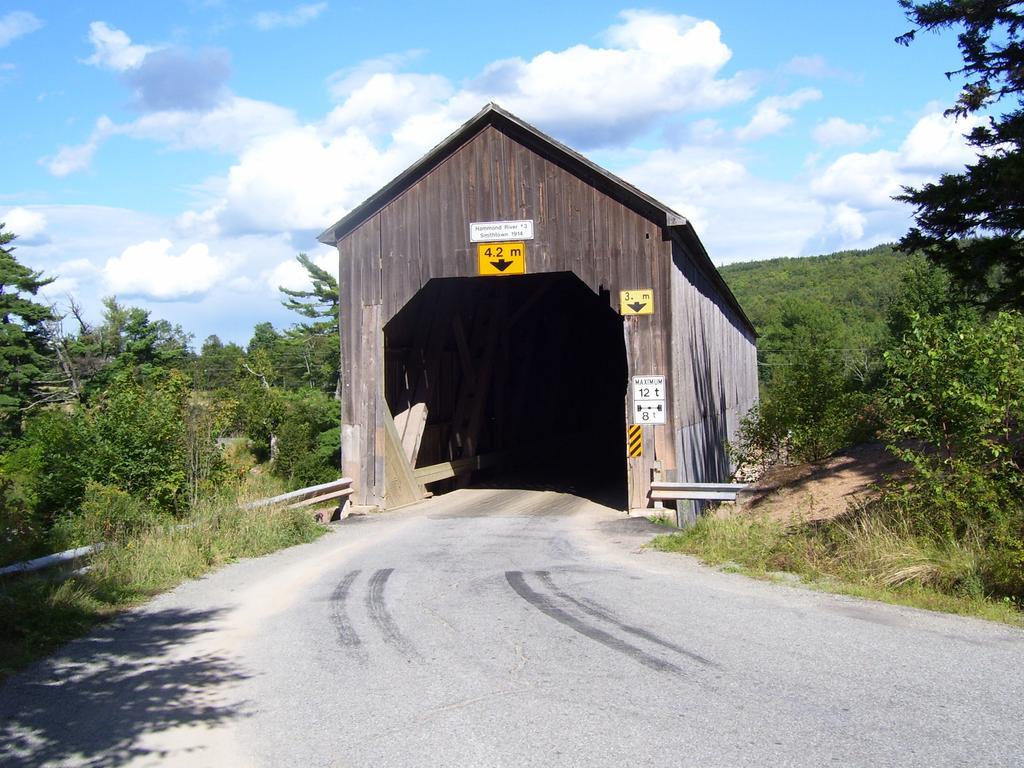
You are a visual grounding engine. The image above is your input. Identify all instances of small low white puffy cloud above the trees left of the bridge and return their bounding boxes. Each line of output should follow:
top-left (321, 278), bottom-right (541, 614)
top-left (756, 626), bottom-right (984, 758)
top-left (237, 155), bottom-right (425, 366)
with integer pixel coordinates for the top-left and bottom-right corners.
top-left (103, 239), bottom-right (234, 300)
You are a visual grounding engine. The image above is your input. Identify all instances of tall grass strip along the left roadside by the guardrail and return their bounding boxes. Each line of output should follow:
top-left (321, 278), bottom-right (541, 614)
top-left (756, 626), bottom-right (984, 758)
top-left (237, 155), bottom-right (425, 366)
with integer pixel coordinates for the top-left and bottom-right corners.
top-left (0, 476), bottom-right (327, 680)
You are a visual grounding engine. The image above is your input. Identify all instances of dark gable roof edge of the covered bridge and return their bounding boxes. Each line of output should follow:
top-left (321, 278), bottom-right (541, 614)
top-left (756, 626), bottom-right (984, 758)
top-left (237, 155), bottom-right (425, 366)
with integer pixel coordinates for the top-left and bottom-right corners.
top-left (316, 102), bottom-right (757, 336)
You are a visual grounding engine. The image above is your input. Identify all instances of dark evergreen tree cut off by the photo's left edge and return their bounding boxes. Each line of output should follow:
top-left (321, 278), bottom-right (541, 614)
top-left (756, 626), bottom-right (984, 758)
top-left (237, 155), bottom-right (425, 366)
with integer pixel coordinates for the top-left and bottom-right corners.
top-left (0, 223), bottom-right (54, 440)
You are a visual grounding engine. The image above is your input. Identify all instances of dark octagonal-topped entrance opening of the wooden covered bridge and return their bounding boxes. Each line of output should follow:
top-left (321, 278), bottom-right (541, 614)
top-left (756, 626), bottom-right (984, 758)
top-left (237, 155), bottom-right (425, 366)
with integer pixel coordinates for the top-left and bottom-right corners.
top-left (384, 272), bottom-right (628, 507)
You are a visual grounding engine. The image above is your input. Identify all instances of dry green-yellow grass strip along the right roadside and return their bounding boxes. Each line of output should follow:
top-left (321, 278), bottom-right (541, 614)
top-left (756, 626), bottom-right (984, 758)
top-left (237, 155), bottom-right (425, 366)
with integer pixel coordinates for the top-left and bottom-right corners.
top-left (651, 508), bottom-right (1024, 627)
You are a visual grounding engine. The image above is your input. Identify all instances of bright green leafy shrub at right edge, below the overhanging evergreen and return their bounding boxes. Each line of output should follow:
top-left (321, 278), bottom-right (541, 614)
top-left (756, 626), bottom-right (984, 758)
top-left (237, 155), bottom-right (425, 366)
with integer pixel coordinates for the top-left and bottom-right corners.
top-left (883, 312), bottom-right (1024, 596)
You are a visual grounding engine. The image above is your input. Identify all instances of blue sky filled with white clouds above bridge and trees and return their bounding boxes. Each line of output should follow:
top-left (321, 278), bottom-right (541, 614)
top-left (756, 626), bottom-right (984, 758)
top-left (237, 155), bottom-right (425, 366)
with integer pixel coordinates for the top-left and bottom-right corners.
top-left (0, 0), bottom-right (973, 343)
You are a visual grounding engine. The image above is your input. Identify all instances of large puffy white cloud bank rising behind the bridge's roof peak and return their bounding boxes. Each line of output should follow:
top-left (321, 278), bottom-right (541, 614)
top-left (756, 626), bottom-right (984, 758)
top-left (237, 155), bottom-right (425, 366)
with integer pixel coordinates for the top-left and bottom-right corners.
top-left (181, 11), bottom-right (761, 232)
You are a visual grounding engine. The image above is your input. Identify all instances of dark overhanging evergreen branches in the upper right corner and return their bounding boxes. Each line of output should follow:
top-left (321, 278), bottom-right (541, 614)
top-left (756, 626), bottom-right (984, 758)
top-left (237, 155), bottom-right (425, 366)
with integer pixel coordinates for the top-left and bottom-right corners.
top-left (897, 0), bottom-right (1024, 308)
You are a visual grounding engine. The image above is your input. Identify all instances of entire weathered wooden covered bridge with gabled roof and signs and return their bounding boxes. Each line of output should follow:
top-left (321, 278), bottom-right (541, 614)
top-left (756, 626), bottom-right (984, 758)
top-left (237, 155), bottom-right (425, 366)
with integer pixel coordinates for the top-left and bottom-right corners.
top-left (319, 104), bottom-right (758, 518)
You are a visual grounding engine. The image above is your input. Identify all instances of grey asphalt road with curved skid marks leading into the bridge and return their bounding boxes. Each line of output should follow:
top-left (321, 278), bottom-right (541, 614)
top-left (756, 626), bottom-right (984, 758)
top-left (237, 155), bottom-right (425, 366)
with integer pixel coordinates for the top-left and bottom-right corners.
top-left (0, 489), bottom-right (1024, 767)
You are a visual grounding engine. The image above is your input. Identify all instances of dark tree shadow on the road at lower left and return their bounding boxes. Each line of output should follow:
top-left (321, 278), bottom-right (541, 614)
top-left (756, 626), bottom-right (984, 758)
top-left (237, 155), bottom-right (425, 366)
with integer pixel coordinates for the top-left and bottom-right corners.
top-left (0, 609), bottom-right (248, 767)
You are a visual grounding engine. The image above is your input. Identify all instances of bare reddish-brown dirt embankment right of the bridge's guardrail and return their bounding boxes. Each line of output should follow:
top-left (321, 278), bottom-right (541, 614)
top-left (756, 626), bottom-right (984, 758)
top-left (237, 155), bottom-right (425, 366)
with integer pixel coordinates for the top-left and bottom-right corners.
top-left (723, 443), bottom-right (906, 520)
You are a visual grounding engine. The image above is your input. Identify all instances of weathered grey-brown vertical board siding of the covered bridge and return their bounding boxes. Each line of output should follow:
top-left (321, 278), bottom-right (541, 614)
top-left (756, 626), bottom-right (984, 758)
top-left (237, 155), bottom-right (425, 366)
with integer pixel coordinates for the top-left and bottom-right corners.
top-left (338, 125), bottom-right (757, 507)
